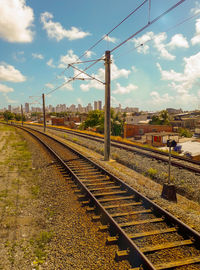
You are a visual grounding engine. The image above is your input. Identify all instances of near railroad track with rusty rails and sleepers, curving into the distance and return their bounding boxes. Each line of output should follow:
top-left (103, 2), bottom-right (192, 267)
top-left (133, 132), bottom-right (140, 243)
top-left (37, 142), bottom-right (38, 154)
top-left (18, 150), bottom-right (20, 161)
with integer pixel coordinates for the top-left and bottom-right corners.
top-left (16, 127), bottom-right (200, 270)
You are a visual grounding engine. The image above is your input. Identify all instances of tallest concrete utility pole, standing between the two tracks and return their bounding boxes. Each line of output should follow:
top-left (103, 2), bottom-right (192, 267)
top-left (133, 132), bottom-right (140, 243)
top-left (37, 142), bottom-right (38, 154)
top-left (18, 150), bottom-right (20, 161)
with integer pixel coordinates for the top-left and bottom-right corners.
top-left (104, 51), bottom-right (111, 161)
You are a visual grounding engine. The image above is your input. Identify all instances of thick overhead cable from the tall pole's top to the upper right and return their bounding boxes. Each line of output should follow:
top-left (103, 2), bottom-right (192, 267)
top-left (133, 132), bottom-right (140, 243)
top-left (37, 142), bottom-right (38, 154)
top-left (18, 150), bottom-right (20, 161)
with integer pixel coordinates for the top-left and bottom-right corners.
top-left (110, 0), bottom-right (186, 53)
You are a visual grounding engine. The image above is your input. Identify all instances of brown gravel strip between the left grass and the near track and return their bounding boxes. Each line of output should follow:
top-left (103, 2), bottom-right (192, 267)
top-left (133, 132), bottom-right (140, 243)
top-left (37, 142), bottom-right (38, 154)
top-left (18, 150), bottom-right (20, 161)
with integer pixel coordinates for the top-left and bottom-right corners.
top-left (16, 126), bottom-right (130, 270)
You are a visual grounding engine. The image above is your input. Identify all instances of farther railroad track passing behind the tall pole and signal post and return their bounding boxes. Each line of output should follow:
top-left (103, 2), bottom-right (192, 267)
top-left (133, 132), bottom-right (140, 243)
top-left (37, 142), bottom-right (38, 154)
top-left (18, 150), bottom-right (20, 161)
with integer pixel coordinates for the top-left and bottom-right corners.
top-left (24, 123), bottom-right (200, 174)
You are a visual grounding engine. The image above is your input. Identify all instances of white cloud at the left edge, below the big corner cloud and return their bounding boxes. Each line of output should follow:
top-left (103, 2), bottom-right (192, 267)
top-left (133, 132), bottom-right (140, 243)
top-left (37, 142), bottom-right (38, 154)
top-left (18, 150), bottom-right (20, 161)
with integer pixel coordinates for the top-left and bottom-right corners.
top-left (0, 63), bottom-right (26, 82)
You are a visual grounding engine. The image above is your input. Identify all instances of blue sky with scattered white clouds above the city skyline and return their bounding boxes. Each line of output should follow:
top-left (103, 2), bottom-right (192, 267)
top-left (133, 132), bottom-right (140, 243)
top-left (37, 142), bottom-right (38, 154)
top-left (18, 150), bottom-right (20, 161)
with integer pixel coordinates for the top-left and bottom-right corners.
top-left (0, 0), bottom-right (200, 111)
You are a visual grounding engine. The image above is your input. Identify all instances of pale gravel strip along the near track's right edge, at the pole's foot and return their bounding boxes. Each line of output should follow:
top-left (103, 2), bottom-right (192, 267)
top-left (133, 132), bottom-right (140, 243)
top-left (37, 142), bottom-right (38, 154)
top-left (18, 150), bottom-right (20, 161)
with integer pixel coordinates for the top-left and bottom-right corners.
top-left (24, 124), bottom-right (200, 232)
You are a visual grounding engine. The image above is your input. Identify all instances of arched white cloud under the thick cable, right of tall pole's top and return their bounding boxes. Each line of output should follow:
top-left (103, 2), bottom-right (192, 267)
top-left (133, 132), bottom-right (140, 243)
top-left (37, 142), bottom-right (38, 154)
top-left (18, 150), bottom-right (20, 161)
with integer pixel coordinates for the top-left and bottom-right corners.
top-left (132, 32), bottom-right (175, 60)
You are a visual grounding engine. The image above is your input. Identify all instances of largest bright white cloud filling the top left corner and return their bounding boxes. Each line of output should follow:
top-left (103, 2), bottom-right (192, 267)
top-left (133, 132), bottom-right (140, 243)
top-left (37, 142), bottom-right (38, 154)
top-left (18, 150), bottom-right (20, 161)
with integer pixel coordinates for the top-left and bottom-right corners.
top-left (0, 0), bottom-right (34, 42)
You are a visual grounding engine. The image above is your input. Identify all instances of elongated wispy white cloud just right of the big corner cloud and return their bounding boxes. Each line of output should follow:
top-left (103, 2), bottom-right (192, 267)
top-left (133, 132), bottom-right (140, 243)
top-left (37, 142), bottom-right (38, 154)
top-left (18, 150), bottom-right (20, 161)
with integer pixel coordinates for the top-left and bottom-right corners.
top-left (41, 12), bottom-right (90, 41)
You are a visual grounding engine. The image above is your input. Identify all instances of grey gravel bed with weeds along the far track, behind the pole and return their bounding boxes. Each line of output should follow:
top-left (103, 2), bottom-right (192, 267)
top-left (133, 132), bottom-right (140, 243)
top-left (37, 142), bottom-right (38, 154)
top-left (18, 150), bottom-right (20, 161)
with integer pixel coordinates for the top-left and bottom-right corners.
top-left (35, 126), bottom-right (200, 203)
